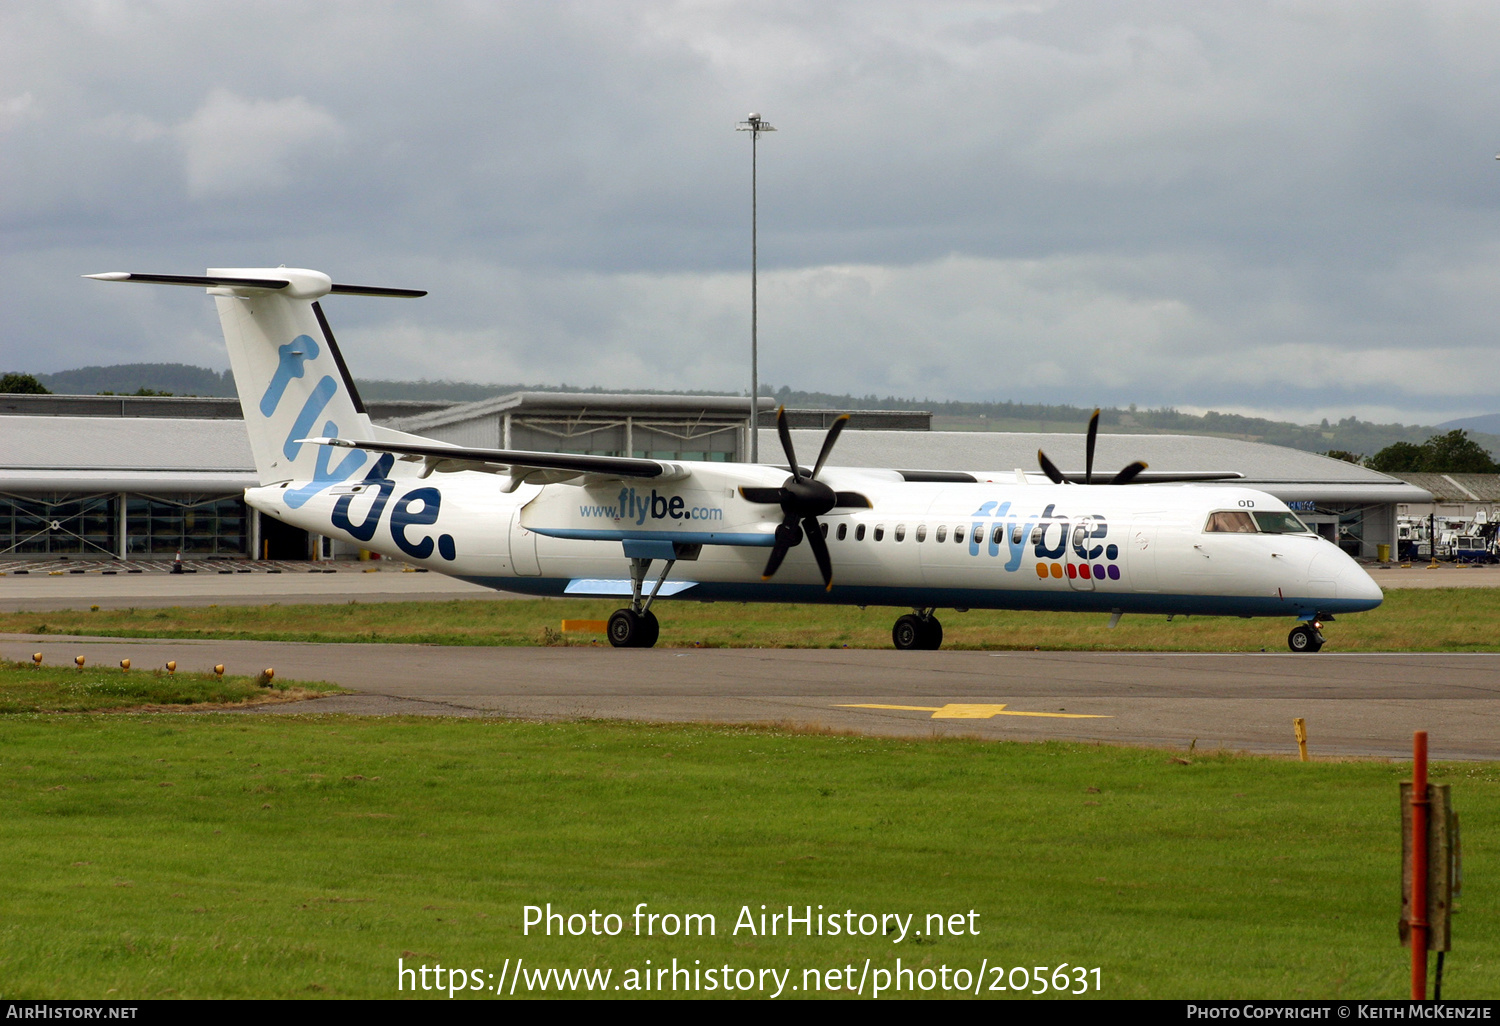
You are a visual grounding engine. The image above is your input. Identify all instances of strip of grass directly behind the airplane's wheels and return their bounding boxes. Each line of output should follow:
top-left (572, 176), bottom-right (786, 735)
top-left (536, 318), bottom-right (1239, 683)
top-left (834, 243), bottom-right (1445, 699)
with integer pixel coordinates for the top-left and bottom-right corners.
top-left (0, 588), bottom-right (1500, 653)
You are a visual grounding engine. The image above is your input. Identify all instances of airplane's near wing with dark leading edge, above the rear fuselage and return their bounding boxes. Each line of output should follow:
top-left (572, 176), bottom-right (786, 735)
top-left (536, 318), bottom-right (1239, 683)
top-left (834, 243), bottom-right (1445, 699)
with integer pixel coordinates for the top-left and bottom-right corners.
top-left (302, 438), bottom-right (687, 492)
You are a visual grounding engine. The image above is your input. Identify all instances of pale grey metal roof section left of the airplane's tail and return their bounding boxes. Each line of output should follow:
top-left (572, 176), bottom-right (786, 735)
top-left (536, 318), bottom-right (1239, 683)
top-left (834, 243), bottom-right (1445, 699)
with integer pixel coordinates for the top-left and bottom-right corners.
top-left (0, 417), bottom-right (255, 474)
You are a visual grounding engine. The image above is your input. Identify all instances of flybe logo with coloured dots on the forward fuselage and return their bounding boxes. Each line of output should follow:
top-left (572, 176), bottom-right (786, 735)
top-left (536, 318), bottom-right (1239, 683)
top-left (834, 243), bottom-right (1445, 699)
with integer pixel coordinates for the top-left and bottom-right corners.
top-left (965, 500), bottom-right (1121, 581)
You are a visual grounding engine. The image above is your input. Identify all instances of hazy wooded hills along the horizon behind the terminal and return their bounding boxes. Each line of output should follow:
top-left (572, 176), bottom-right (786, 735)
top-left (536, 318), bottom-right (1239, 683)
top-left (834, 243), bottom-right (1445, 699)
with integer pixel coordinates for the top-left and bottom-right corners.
top-left (20, 363), bottom-right (1500, 456)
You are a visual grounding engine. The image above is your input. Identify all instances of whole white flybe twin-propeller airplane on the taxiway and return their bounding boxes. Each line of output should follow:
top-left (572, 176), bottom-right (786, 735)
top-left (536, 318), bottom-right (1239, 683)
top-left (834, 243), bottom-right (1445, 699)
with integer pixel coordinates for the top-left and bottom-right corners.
top-left (89, 267), bottom-right (1383, 653)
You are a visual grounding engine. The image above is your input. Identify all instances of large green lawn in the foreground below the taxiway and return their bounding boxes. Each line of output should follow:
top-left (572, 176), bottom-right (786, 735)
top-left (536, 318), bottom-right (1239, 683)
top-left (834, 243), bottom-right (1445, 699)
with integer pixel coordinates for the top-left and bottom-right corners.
top-left (0, 714), bottom-right (1500, 1001)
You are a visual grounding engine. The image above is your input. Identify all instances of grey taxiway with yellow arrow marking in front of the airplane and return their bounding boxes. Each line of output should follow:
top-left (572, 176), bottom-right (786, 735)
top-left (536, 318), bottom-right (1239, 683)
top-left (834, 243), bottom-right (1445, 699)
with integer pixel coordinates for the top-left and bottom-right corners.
top-left (0, 635), bottom-right (1500, 759)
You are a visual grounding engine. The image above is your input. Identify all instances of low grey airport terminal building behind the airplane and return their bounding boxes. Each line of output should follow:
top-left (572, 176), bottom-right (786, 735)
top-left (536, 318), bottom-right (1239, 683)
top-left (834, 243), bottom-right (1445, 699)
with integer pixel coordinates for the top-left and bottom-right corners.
top-left (0, 392), bottom-right (1433, 561)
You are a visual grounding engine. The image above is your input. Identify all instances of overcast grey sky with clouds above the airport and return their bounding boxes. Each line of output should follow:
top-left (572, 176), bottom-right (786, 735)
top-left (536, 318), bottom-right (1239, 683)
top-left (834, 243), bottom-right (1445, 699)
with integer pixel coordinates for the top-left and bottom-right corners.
top-left (0, 0), bottom-right (1500, 423)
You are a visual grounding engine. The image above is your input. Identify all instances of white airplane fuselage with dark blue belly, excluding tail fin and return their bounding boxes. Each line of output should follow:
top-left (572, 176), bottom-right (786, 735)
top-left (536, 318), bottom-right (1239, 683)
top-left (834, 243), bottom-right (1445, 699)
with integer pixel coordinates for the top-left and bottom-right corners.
top-left (248, 464), bottom-right (1382, 618)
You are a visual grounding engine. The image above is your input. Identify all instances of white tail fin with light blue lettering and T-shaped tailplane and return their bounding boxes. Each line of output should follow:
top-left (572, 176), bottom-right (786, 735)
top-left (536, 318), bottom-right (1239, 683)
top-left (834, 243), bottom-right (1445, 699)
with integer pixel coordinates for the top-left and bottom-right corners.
top-left (89, 267), bottom-right (426, 506)
